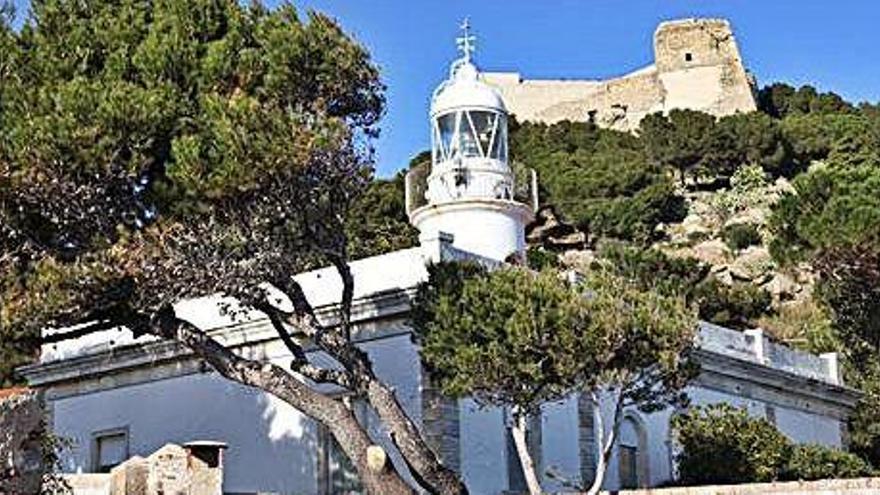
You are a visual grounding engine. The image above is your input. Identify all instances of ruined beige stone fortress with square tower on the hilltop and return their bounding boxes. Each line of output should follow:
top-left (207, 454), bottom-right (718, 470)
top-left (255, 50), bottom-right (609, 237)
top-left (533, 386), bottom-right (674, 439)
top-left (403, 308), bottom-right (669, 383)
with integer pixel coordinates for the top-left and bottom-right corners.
top-left (482, 19), bottom-right (756, 131)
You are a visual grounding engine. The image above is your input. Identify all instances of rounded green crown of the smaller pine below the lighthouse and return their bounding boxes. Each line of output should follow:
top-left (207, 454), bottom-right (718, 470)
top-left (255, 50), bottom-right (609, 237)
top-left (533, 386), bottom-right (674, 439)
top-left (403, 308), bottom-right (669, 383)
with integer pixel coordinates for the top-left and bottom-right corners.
top-left (413, 263), bottom-right (696, 412)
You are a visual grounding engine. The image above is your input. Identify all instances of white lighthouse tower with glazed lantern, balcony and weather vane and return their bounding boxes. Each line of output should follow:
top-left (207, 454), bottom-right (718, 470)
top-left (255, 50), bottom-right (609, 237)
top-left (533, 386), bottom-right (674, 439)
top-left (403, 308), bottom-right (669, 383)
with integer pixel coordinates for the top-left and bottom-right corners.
top-left (407, 20), bottom-right (534, 261)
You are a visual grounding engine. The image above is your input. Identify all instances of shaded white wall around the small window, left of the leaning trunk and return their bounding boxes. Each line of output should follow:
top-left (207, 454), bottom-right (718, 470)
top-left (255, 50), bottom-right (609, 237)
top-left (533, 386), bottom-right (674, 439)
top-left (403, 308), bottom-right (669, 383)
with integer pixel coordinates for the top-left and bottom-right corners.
top-left (54, 374), bottom-right (317, 493)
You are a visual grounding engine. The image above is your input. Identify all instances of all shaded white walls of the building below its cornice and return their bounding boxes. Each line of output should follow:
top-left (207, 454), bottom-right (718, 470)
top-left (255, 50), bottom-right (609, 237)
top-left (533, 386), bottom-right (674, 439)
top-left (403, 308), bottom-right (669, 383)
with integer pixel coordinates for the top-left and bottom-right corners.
top-left (44, 334), bottom-right (841, 494)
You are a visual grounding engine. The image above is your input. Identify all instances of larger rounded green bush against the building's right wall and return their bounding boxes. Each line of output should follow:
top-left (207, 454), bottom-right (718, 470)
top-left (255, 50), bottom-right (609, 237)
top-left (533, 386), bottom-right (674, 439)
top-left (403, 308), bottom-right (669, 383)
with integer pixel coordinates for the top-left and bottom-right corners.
top-left (672, 404), bottom-right (791, 485)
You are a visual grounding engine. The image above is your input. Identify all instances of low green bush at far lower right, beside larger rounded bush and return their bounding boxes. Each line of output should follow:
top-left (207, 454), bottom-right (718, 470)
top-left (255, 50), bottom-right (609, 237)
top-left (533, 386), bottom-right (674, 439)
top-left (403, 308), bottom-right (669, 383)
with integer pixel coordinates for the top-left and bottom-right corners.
top-left (783, 445), bottom-right (874, 481)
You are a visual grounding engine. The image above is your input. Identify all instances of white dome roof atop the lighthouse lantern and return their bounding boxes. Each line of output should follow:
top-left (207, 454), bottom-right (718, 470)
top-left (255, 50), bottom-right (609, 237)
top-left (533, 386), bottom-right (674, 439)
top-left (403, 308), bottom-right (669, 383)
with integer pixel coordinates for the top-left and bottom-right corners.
top-left (431, 60), bottom-right (507, 117)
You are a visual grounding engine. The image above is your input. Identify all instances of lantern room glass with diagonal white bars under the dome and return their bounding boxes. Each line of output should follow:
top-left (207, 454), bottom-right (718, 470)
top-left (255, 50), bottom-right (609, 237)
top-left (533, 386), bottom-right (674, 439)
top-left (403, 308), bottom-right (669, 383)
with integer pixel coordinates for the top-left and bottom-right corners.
top-left (433, 110), bottom-right (507, 162)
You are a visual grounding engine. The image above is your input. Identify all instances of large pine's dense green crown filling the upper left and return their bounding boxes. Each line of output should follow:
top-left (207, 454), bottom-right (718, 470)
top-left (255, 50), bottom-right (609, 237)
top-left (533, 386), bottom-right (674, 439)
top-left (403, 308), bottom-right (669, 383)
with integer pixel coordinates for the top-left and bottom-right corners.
top-left (0, 0), bottom-right (384, 383)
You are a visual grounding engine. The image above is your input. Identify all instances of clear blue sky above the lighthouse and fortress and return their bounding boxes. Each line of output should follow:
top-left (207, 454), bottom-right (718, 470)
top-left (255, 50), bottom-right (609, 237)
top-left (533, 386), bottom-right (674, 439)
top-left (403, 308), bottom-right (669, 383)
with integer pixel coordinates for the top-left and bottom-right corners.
top-left (16, 0), bottom-right (880, 176)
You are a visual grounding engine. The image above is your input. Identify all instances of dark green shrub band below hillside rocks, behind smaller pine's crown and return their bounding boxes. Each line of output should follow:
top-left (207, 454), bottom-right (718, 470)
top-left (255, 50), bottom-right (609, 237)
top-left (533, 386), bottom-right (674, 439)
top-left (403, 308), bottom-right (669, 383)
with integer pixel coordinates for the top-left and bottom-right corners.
top-left (599, 243), bottom-right (771, 329)
